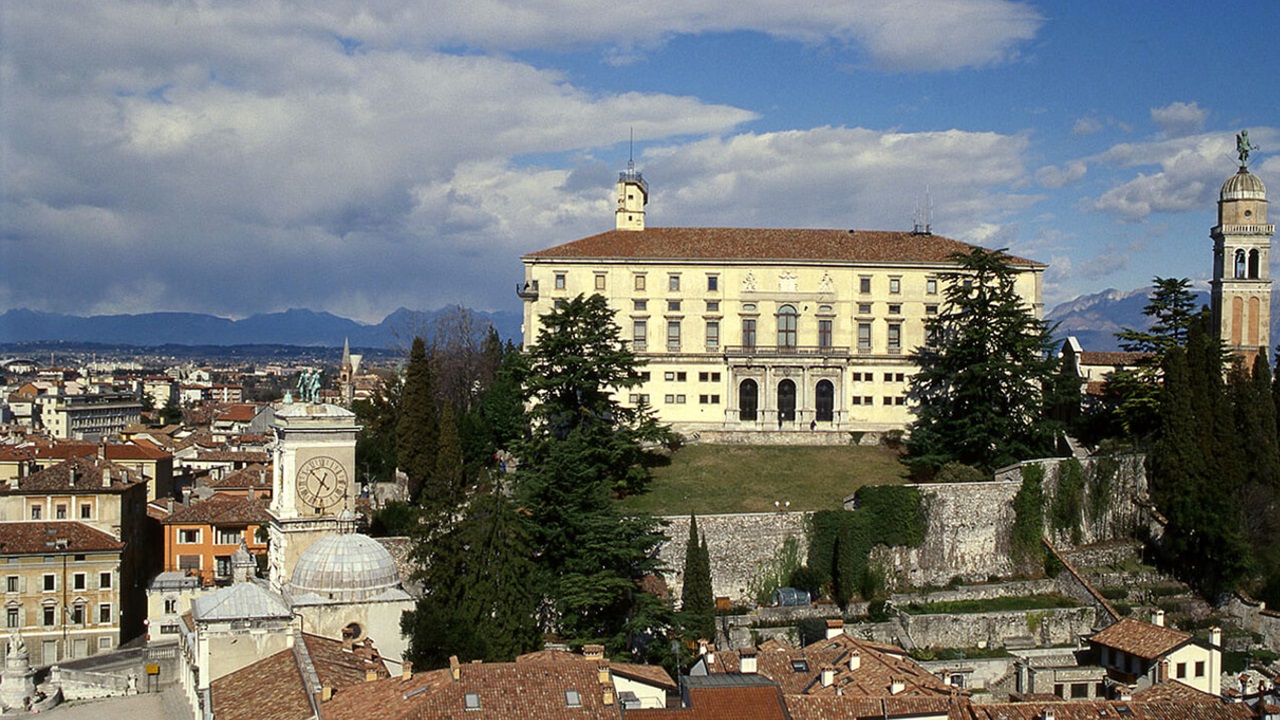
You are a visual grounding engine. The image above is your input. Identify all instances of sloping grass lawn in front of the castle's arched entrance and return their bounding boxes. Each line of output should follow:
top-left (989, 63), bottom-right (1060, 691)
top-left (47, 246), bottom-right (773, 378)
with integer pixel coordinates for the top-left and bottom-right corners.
top-left (622, 445), bottom-right (906, 515)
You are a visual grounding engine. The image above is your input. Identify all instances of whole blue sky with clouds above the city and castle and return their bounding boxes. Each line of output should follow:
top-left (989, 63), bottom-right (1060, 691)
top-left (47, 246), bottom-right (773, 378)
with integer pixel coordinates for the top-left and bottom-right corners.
top-left (0, 0), bottom-right (1280, 322)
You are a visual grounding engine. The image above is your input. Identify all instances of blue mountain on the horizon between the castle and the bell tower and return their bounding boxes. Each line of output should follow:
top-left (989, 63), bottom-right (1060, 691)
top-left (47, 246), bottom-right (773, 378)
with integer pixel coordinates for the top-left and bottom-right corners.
top-left (1044, 287), bottom-right (1280, 351)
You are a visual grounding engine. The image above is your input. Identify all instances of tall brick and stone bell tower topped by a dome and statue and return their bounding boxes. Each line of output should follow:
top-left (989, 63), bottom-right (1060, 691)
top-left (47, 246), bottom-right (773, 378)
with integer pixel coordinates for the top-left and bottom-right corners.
top-left (1210, 131), bottom-right (1276, 366)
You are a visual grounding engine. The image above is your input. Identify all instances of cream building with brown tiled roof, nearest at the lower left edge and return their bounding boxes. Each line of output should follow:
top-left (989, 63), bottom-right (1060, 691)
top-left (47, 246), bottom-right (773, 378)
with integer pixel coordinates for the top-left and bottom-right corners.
top-left (0, 520), bottom-right (124, 665)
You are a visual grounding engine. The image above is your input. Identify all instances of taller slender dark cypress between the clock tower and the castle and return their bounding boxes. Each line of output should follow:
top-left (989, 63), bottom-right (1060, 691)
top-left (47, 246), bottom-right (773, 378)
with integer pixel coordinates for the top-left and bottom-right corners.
top-left (396, 337), bottom-right (440, 502)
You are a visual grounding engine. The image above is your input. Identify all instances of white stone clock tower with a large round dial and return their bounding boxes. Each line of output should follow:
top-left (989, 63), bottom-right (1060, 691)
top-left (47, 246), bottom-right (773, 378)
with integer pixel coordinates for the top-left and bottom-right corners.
top-left (268, 401), bottom-right (360, 591)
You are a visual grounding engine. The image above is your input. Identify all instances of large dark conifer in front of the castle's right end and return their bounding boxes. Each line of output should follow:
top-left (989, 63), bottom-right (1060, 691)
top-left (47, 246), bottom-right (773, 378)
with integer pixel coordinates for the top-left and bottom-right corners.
top-left (908, 247), bottom-right (1059, 473)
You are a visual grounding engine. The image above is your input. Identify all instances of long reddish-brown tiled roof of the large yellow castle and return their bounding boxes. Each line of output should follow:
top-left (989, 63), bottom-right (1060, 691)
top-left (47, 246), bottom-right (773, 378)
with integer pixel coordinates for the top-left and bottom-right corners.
top-left (525, 228), bottom-right (1044, 268)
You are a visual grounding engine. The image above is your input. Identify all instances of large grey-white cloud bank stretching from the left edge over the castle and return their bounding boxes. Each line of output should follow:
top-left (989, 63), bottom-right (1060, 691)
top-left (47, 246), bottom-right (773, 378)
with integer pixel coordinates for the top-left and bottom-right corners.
top-left (0, 0), bottom-right (1042, 319)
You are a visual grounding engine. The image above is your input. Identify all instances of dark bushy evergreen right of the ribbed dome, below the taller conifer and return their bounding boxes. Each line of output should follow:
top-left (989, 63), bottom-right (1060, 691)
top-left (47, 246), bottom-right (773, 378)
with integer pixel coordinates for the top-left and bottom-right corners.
top-left (401, 487), bottom-right (541, 669)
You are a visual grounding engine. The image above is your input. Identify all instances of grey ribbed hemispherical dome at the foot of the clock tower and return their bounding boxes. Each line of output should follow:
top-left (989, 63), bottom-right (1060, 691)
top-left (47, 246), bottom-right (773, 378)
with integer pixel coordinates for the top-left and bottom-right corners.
top-left (289, 533), bottom-right (399, 601)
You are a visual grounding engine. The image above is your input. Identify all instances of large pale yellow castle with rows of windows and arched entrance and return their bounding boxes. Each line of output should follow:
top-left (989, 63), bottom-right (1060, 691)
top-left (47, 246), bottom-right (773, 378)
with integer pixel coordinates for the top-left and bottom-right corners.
top-left (517, 168), bottom-right (1046, 430)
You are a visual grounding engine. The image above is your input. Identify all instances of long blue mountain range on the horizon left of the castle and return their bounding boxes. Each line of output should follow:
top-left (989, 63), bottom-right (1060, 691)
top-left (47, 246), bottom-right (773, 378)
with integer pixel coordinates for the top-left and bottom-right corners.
top-left (0, 307), bottom-right (522, 348)
